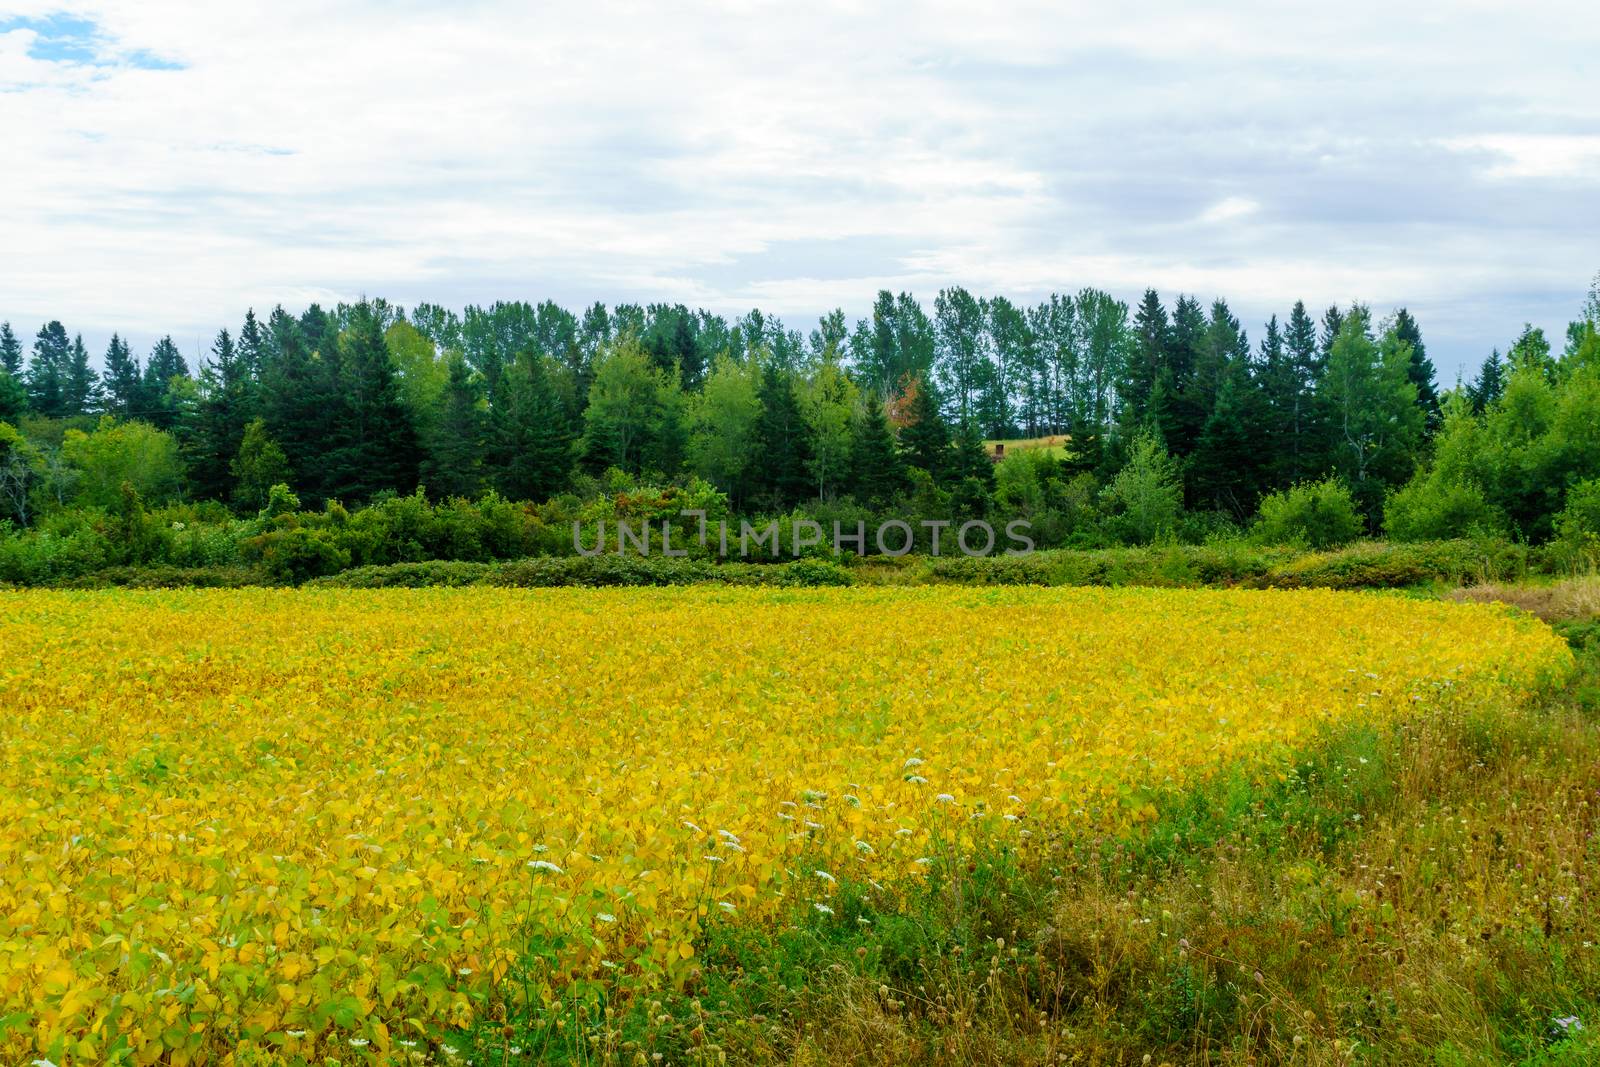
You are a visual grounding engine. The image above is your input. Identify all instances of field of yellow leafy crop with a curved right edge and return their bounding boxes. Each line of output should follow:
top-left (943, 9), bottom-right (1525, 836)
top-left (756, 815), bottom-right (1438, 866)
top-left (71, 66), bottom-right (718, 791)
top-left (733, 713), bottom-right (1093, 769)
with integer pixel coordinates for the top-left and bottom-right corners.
top-left (0, 587), bottom-right (1570, 1064)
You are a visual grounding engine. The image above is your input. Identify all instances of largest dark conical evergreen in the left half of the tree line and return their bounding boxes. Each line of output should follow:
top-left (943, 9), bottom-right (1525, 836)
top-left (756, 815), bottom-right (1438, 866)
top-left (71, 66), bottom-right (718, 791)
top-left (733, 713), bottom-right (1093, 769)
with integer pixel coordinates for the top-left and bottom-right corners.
top-left (326, 301), bottom-right (418, 501)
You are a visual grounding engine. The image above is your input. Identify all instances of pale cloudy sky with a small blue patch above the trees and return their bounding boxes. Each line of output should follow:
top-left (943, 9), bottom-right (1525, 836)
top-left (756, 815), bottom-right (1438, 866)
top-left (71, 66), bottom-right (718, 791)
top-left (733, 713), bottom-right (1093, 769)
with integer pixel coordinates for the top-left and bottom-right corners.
top-left (0, 0), bottom-right (1600, 384)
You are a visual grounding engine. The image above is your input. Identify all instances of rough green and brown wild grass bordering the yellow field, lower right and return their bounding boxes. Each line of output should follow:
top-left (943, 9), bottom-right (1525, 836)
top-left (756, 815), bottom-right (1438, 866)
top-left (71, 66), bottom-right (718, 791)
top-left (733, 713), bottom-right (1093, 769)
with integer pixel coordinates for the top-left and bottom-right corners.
top-left (462, 590), bottom-right (1600, 1065)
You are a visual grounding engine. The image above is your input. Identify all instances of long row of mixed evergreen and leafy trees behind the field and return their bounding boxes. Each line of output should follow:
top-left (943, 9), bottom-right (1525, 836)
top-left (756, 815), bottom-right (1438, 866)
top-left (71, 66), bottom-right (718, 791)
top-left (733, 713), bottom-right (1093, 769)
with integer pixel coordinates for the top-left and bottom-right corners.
top-left (0, 275), bottom-right (1600, 556)
